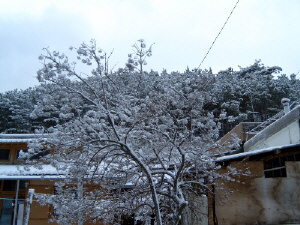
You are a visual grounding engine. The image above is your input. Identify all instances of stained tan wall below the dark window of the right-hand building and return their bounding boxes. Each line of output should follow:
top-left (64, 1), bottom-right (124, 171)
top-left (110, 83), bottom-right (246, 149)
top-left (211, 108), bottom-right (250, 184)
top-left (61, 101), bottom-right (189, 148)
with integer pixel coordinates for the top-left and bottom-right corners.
top-left (215, 161), bottom-right (300, 225)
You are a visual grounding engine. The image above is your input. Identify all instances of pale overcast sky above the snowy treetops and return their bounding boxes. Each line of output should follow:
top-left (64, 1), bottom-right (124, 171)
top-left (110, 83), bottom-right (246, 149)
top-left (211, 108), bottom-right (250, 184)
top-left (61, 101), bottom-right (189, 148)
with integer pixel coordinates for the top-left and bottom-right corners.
top-left (0, 0), bottom-right (300, 92)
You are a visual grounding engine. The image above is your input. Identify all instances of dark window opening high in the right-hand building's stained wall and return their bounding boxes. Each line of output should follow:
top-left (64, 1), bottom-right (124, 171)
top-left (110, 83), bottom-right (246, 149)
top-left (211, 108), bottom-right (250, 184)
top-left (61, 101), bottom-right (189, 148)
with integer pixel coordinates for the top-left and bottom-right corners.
top-left (264, 154), bottom-right (300, 178)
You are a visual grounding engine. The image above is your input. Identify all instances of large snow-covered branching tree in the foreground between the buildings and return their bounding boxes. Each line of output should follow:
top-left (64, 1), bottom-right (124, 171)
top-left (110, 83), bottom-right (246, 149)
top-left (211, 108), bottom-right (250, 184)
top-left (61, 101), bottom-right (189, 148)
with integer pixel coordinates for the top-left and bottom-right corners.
top-left (25, 41), bottom-right (234, 225)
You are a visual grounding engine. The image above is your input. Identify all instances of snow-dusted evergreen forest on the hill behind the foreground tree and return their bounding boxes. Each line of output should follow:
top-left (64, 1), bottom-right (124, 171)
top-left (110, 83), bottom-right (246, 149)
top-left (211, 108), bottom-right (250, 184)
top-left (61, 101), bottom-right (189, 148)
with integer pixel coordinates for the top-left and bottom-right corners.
top-left (0, 43), bottom-right (300, 135)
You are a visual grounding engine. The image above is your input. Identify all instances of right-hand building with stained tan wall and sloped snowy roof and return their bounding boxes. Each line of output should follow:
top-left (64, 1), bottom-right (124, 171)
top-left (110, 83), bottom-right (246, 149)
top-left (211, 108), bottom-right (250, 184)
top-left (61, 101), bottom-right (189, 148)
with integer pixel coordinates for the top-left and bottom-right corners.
top-left (209, 99), bottom-right (300, 225)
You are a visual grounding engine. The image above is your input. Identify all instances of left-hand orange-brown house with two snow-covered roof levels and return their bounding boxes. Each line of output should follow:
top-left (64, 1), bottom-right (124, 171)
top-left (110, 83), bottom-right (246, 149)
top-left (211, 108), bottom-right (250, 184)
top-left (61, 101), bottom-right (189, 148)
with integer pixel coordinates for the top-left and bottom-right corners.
top-left (0, 134), bottom-right (61, 225)
